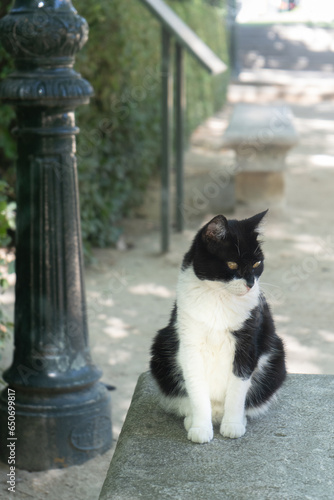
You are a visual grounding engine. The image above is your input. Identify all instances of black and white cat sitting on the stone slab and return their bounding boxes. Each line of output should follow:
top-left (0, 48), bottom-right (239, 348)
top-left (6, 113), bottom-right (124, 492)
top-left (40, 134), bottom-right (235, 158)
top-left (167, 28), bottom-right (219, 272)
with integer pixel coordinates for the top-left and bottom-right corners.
top-left (150, 212), bottom-right (286, 443)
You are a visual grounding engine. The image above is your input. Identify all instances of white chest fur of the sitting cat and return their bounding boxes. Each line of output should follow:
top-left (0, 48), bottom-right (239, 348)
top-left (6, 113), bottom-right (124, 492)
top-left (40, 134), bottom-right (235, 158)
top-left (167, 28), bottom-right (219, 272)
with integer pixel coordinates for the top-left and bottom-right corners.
top-left (177, 268), bottom-right (258, 412)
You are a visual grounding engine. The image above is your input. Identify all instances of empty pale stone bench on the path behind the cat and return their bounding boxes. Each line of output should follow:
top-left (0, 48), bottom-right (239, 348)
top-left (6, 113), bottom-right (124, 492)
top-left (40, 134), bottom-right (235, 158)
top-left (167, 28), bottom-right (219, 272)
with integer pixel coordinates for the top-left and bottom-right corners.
top-left (223, 104), bottom-right (298, 203)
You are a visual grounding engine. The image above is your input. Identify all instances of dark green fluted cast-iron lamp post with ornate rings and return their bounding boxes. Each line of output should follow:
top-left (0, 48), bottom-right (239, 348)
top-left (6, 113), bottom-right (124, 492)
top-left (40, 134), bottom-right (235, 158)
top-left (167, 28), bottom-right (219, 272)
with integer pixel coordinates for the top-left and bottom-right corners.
top-left (0, 0), bottom-right (112, 471)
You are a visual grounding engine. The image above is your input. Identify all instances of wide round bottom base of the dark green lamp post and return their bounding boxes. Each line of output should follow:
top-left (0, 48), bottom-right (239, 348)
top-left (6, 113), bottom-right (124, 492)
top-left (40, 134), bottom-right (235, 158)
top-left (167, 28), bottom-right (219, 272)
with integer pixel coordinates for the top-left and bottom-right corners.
top-left (0, 383), bottom-right (111, 471)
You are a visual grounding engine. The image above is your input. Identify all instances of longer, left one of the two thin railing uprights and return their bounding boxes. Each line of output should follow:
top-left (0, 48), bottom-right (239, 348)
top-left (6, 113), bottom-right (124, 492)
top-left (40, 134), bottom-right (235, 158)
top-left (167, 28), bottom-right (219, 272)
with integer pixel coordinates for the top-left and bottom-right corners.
top-left (161, 27), bottom-right (173, 252)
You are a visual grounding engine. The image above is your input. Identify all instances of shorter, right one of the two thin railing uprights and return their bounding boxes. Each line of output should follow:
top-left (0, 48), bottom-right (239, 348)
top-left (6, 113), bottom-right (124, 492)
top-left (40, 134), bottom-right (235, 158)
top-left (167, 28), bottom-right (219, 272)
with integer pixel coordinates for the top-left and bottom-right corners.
top-left (175, 43), bottom-right (185, 232)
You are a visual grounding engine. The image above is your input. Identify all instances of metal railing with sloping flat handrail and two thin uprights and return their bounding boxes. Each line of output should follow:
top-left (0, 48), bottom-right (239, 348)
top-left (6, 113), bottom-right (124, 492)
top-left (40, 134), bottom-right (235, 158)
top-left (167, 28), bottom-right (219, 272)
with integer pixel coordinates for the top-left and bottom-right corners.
top-left (141, 0), bottom-right (227, 252)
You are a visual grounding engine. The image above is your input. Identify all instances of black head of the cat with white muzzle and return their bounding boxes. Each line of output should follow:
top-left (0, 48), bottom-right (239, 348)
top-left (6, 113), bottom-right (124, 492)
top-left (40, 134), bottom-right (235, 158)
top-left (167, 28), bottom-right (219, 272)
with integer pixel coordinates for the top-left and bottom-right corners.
top-left (183, 211), bottom-right (267, 295)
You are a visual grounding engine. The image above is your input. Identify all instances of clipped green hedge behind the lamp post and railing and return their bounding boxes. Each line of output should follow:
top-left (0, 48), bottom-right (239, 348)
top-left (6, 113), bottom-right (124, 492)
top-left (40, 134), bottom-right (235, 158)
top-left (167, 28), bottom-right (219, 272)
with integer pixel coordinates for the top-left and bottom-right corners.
top-left (0, 0), bottom-right (228, 254)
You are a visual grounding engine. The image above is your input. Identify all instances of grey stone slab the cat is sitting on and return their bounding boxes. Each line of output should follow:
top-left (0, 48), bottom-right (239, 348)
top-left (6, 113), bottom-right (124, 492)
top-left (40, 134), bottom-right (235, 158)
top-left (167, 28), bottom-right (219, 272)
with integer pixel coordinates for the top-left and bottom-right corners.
top-left (100, 373), bottom-right (334, 500)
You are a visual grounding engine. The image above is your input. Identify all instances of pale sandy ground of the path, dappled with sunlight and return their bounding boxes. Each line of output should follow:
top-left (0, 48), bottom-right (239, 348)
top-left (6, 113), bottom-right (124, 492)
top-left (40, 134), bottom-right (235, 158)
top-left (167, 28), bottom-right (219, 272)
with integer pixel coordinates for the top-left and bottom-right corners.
top-left (0, 86), bottom-right (334, 500)
